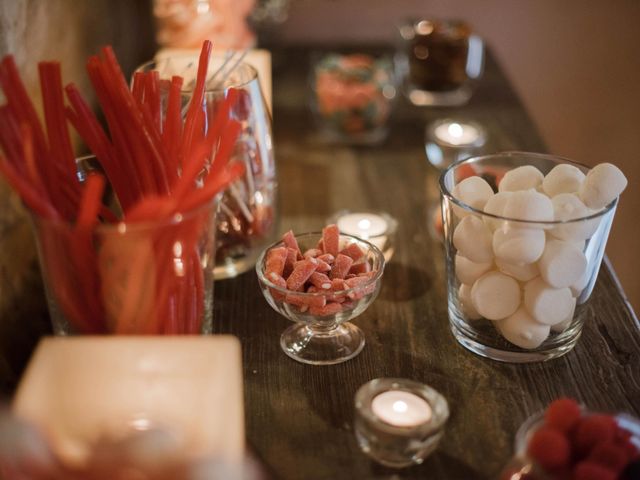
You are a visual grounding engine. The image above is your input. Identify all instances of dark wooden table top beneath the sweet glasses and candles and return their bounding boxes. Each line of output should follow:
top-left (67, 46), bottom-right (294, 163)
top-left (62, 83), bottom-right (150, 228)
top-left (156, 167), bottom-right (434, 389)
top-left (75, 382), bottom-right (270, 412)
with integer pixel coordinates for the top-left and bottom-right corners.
top-left (215, 48), bottom-right (640, 480)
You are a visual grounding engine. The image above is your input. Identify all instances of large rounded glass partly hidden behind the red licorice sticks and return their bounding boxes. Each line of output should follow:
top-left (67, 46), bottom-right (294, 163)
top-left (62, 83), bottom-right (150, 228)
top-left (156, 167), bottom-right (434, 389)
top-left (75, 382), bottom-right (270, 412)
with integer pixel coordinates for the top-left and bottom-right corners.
top-left (134, 55), bottom-right (277, 280)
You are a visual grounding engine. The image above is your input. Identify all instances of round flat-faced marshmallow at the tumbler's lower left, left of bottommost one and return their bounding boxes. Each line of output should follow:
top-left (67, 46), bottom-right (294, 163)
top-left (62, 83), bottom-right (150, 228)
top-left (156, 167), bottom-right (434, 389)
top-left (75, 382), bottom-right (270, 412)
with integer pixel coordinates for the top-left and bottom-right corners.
top-left (471, 271), bottom-right (520, 320)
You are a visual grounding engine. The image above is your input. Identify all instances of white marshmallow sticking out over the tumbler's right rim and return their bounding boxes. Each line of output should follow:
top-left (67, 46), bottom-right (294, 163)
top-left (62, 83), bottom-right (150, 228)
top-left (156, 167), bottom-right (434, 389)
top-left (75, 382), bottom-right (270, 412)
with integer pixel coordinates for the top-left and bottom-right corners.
top-left (578, 163), bottom-right (627, 210)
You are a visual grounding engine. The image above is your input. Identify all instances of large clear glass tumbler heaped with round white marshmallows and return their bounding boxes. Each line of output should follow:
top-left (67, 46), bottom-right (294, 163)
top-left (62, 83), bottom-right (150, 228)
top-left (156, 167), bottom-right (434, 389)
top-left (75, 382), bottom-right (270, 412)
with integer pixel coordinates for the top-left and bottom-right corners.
top-left (440, 152), bottom-right (627, 363)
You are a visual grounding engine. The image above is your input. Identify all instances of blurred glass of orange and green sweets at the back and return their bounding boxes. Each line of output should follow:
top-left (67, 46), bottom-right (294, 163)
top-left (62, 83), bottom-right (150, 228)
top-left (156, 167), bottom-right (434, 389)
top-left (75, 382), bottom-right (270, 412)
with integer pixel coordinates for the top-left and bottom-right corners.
top-left (311, 53), bottom-right (396, 144)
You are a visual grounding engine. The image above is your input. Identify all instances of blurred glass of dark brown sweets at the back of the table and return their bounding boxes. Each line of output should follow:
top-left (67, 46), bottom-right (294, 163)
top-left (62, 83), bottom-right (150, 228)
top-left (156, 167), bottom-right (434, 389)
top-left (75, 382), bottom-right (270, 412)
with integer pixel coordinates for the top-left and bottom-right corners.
top-left (396, 19), bottom-right (484, 106)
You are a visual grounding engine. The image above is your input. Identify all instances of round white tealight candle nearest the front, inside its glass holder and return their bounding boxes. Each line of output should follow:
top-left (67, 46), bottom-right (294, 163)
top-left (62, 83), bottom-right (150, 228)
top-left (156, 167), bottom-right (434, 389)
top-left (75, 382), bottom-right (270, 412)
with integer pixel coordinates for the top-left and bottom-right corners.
top-left (371, 390), bottom-right (433, 427)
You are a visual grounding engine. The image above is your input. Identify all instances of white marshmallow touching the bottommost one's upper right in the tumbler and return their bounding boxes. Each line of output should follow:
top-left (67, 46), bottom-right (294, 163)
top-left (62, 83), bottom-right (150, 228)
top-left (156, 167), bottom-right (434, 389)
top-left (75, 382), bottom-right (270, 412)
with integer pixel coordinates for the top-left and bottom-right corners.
top-left (524, 277), bottom-right (575, 325)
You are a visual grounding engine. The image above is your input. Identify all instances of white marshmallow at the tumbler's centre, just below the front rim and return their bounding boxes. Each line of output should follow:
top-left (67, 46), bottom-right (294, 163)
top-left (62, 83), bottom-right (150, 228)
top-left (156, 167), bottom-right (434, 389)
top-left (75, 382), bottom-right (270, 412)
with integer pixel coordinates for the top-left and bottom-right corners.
top-left (492, 226), bottom-right (545, 264)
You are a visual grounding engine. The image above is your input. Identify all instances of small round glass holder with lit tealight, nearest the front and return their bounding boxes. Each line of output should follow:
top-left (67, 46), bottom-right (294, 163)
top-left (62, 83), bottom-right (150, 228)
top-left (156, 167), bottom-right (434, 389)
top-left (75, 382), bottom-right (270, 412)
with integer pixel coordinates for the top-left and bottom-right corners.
top-left (354, 378), bottom-right (449, 468)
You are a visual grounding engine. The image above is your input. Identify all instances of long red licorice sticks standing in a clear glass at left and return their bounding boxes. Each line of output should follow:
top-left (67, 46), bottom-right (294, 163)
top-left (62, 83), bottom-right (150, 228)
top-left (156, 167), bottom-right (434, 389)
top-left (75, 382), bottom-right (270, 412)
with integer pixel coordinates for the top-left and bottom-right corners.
top-left (0, 41), bottom-right (244, 333)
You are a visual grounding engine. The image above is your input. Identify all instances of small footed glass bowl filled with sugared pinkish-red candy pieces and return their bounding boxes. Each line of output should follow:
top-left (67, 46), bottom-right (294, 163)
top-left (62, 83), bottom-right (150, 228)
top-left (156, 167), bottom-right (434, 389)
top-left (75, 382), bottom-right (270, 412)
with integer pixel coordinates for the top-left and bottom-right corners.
top-left (256, 231), bottom-right (385, 365)
